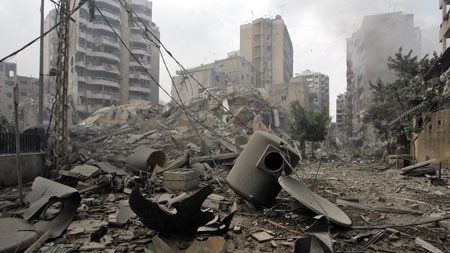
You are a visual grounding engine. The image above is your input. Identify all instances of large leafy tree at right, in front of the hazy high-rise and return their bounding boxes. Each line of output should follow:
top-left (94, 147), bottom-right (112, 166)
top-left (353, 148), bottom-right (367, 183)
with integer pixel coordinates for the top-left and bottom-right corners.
top-left (364, 48), bottom-right (444, 154)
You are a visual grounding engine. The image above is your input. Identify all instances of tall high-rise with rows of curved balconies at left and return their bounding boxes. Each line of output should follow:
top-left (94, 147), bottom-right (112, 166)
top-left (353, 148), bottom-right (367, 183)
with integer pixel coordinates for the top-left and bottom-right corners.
top-left (44, 0), bottom-right (160, 118)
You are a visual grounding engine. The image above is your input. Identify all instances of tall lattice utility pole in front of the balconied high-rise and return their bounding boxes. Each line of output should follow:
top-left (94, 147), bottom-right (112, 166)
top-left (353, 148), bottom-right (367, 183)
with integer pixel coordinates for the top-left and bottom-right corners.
top-left (53, 0), bottom-right (70, 169)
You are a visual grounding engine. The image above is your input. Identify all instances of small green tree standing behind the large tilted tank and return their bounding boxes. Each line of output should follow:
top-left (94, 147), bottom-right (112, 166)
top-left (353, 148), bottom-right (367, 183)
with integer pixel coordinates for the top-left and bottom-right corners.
top-left (290, 100), bottom-right (329, 156)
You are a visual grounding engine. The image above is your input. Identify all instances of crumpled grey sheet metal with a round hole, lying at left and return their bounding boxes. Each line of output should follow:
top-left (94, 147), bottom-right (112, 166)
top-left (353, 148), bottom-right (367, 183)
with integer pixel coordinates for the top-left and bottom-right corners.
top-left (23, 177), bottom-right (81, 238)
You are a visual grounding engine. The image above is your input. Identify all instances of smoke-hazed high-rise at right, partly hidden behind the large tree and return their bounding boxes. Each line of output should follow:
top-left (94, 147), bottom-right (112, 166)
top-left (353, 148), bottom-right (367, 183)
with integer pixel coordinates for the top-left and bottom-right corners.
top-left (347, 12), bottom-right (421, 144)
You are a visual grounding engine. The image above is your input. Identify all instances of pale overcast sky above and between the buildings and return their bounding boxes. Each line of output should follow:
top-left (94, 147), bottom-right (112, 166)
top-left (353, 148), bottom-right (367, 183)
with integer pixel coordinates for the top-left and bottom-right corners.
top-left (0, 0), bottom-right (441, 120)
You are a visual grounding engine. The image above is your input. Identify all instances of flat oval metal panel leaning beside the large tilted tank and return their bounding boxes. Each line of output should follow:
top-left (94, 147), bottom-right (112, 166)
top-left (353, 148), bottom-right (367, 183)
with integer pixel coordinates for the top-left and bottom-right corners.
top-left (278, 176), bottom-right (352, 227)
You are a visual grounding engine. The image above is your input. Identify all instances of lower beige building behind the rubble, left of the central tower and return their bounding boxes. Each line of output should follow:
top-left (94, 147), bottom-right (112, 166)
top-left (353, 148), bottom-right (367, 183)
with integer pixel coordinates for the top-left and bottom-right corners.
top-left (171, 55), bottom-right (255, 102)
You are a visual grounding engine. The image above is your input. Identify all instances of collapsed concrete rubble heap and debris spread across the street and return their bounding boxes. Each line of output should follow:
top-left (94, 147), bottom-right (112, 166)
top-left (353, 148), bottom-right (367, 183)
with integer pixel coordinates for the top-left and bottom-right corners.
top-left (0, 86), bottom-right (450, 253)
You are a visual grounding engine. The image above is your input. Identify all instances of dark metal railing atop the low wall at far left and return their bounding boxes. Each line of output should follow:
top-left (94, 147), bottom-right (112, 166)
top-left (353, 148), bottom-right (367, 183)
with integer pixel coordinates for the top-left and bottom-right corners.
top-left (0, 133), bottom-right (41, 154)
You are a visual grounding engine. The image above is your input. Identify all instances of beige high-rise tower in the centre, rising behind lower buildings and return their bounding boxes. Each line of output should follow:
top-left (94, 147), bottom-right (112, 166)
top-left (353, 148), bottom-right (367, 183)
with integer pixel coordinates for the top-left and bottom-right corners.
top-left (240, 15), bottom-right (294, 88)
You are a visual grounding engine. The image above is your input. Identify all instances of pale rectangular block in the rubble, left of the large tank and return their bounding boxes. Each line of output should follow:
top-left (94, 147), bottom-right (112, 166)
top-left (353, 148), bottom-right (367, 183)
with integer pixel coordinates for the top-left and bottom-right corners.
top-left (163, 169), bottom-right (200, 191)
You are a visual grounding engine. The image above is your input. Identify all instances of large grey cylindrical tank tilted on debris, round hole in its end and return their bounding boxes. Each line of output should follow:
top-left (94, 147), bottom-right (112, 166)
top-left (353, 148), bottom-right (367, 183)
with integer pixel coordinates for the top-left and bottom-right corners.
top-left (226, 131), bottom-right (300, 207)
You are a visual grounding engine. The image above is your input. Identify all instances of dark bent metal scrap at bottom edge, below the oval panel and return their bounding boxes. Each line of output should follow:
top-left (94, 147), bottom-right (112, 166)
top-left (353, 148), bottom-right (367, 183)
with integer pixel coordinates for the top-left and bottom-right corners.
top-left (294, 215), bottom-right (334, 253)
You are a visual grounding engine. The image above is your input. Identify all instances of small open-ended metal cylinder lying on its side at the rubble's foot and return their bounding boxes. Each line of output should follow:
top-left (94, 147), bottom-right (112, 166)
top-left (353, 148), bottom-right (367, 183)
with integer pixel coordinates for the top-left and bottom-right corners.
top-left (126, 146), bottom-right (167, 174)
